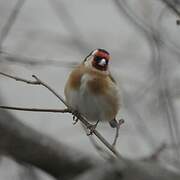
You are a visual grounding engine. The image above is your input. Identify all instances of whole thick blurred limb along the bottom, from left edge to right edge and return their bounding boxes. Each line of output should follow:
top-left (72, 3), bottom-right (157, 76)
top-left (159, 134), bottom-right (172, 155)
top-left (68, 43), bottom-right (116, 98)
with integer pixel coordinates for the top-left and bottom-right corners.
top-left (0, 108), bottom-right (180, 180)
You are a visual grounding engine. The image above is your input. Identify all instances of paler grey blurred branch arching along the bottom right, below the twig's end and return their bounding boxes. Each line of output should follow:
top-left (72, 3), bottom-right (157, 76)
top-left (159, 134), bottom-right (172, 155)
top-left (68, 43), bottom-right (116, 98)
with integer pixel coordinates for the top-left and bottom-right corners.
top-left (75, 160), bottom-right (180, 180)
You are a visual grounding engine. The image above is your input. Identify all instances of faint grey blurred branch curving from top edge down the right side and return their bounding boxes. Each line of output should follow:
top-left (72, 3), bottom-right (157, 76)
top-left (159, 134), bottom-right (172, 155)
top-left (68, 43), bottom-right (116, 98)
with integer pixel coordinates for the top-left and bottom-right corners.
top-left (113, 0), bottom-right (179, 162)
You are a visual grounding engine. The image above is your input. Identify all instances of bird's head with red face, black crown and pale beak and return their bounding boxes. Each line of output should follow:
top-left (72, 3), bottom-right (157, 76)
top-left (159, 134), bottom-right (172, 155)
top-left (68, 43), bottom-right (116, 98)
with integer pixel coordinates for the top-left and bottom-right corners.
top-left (83, 49), bottom-right (110, 71)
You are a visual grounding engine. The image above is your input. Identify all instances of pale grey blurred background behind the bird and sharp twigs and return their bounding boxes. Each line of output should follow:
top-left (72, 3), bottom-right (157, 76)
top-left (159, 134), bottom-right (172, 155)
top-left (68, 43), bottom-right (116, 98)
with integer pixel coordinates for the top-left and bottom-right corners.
top-left (0, 0), bottom-right (180, 180)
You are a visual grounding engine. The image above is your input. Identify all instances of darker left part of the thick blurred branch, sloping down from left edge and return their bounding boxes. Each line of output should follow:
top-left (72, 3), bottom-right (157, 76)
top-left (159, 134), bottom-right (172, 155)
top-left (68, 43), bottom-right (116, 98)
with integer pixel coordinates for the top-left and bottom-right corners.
top-left (0, 110), bottom-right (96, 178)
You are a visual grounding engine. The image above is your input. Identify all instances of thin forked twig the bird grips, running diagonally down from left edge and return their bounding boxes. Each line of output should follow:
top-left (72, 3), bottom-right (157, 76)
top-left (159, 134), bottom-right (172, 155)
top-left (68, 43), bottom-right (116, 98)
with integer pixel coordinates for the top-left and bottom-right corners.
top-left (0, 72), bottom-right (124, 160)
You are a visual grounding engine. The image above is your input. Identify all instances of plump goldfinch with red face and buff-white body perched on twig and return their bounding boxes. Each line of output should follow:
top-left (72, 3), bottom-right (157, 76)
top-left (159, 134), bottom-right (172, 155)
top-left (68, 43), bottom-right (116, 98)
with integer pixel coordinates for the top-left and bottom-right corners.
top-left (64, 49), bottom-right (120, 131)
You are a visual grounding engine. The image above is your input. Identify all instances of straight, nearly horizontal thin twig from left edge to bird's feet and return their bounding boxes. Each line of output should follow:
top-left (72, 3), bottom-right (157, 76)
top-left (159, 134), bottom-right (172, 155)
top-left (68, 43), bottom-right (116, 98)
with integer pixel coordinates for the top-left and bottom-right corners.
top-left (0, 106), bottom-right (70, 113)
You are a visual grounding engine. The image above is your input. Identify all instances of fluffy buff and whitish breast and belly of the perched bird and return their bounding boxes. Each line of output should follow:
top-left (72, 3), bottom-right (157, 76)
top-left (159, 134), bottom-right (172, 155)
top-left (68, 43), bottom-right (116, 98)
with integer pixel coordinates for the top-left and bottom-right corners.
top-left (66, 69), bottom-right (119, 121)
